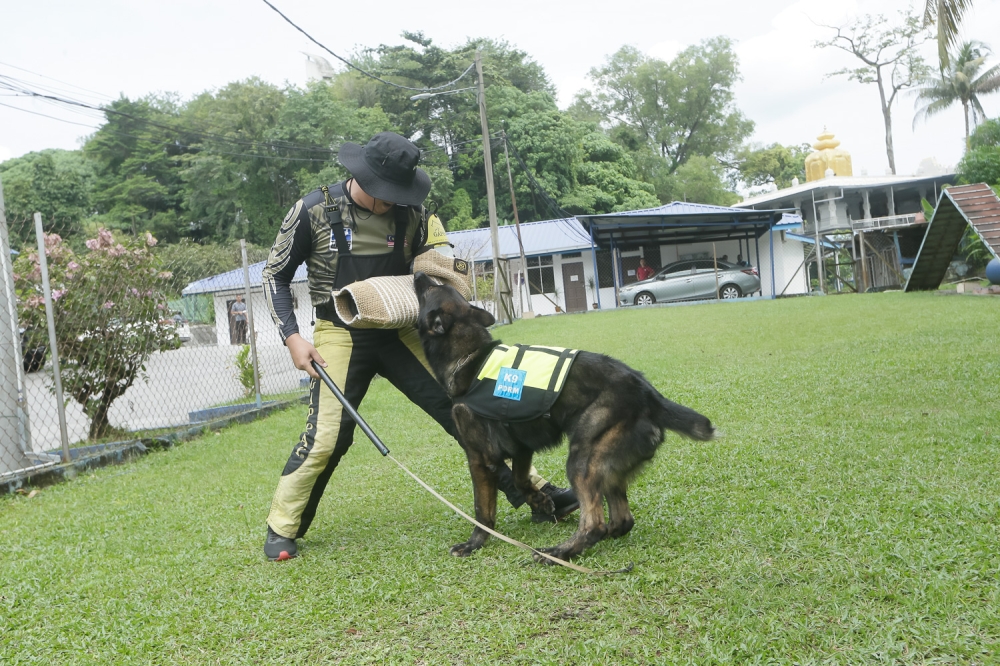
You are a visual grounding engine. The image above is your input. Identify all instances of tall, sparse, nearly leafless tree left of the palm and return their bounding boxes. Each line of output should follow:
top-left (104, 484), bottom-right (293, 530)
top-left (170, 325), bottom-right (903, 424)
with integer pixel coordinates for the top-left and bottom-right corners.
top-left (816, 11), bottom-right (930, 173)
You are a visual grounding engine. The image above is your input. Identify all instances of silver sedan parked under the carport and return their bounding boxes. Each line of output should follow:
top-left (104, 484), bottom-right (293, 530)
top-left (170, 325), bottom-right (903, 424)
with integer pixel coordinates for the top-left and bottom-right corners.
top-left (618, 259), bottom-right (760, 305)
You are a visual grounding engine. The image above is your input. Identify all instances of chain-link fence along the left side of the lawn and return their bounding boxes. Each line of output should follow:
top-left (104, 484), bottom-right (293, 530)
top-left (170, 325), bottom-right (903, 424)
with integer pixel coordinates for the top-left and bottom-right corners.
top-left (0, 205), bottom-right (312, 482)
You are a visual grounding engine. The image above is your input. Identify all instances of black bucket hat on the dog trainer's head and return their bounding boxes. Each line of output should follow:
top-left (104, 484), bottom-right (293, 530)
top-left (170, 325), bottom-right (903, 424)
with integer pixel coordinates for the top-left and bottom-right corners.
top-left (338, 132), bottom-right (431, 206)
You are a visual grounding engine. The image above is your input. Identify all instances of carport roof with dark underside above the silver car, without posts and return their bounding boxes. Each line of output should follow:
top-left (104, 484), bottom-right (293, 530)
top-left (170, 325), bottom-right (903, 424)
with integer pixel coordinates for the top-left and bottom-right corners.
top-left (577, 201), bottom-right (801, 248)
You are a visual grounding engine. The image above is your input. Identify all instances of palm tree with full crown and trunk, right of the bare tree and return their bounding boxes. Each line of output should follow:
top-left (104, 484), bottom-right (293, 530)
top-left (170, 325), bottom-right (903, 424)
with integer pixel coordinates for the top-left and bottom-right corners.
top-left (913, 41), bottom-right (1000, 150)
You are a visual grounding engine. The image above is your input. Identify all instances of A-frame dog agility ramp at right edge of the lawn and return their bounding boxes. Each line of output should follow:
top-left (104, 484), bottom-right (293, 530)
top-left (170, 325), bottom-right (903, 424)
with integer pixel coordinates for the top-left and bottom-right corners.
top-left (903, 183), bottom-right (1000, 291)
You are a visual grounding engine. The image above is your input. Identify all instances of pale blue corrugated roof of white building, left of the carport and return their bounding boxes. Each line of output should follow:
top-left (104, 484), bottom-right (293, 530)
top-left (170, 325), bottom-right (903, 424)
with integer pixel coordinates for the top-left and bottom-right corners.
top-left (448, 217), bottom-right (590, 261)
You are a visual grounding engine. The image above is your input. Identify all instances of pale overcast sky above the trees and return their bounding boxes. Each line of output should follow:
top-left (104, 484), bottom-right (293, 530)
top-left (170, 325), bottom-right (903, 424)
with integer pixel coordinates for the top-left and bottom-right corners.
top-left (0, 0), bottom-right (1000, 184)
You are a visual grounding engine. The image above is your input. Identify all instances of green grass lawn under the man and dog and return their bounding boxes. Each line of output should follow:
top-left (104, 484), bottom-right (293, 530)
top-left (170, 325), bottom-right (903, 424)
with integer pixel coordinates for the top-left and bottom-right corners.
top-left (0, 293), bottom-right (1000, 665)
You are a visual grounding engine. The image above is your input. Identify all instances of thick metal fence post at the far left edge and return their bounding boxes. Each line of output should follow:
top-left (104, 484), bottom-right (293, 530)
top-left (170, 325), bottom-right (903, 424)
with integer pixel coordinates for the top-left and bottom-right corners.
top-left (0, 174), bottom-right (31, 474)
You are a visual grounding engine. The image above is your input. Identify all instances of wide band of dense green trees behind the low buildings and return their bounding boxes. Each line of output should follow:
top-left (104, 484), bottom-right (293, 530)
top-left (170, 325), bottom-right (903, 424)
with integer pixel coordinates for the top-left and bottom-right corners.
top-left (0, 33), bottom-right (780, 256)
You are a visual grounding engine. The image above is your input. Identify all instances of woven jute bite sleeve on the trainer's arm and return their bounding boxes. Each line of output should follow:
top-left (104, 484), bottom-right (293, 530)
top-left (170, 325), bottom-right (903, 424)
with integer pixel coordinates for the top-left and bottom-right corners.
top-left (333, 250), bottom-right (472, 328)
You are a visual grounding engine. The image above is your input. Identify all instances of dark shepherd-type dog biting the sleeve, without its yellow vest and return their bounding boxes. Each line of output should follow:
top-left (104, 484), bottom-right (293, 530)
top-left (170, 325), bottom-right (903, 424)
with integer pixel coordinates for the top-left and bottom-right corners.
top-left (414, 273), bottom-right (715, 563)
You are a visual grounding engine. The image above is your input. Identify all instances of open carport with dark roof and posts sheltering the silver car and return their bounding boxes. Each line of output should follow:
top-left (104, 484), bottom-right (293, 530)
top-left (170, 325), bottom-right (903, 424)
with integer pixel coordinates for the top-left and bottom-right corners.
top-left (577, 201), bottom-right (802, 302)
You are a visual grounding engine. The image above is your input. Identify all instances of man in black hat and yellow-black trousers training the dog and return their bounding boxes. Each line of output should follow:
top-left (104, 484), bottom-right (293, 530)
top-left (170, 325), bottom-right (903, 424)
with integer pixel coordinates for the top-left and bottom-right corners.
top-left (263, 132), bottom-right (579, 561)
